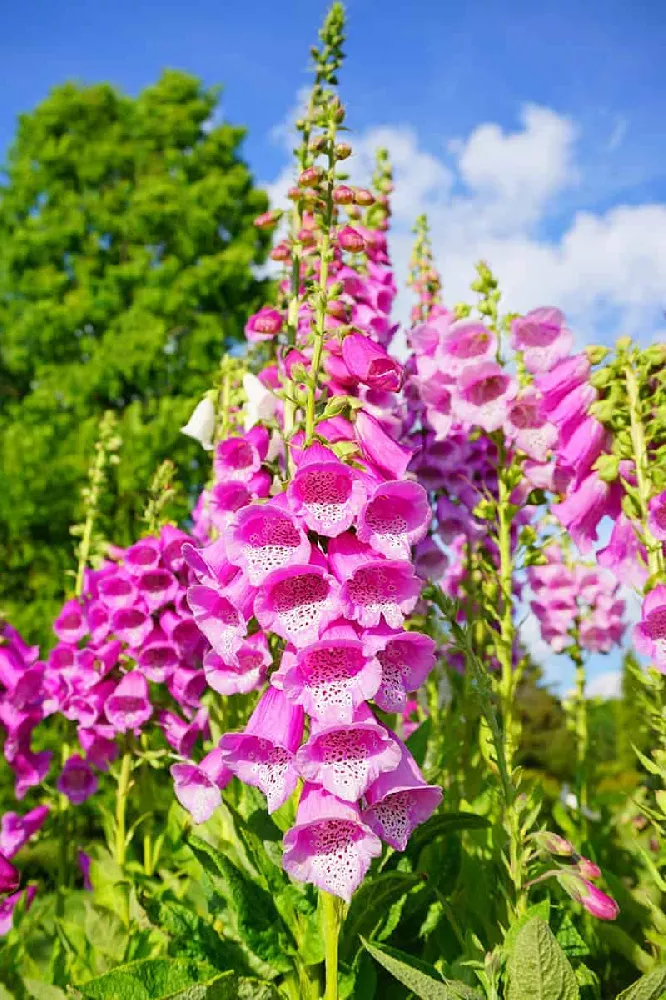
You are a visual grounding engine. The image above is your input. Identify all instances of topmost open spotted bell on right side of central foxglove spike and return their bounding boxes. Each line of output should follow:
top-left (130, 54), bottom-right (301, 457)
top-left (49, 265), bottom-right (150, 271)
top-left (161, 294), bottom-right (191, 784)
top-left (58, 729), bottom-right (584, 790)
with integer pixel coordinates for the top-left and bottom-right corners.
top-left (357, 481), bottom-right (432, 559)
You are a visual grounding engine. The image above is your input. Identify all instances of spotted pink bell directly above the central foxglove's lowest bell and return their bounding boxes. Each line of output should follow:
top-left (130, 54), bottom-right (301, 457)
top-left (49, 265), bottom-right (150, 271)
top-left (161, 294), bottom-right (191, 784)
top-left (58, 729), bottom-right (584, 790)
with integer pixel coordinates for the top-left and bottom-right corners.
top-left (296, 706), bottom-right (401, 802)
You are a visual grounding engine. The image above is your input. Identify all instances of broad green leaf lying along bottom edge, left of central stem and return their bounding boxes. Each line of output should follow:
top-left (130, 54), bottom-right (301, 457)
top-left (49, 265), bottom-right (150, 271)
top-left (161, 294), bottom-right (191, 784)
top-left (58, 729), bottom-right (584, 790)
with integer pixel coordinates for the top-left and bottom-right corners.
top-left (77, 958), bottom-right (230, 1000)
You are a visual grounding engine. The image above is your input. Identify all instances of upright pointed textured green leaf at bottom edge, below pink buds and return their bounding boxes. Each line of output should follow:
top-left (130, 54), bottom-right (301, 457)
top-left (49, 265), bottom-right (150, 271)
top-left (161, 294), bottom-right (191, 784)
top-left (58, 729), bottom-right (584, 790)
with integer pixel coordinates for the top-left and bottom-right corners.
top-left (506, 917), bottom-right (580, 1000)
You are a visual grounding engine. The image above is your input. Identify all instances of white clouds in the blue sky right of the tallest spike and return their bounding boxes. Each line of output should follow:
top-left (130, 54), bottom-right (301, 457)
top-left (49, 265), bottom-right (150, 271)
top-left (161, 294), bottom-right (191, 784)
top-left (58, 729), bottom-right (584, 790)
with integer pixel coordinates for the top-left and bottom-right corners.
top-left (264, 104), bottom-right (666, 344)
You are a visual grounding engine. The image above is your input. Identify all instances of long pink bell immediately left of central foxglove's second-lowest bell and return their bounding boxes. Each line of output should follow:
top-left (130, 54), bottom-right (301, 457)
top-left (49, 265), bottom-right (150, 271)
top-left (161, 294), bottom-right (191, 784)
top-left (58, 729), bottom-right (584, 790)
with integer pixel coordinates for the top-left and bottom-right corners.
top-left (219, 687), bottom-right (304, 813)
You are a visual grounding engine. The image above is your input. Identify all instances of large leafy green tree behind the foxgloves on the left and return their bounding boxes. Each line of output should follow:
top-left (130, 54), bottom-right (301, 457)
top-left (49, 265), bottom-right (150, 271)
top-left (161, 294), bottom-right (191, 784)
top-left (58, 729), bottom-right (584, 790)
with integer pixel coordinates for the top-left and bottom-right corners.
top-left (0, 71), bottom-right (268, 638)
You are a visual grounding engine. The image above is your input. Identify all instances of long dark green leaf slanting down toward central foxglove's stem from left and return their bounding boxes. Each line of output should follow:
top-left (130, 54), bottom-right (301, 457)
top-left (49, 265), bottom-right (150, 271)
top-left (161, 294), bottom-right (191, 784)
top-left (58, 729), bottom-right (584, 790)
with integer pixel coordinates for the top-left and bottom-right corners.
top-left (187, 835), bottom-right (292, 978)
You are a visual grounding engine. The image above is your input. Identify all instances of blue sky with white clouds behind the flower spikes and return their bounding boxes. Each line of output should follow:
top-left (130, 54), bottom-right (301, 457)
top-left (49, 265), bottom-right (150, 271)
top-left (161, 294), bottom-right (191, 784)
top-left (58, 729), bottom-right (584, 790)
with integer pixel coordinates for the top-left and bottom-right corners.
top-left (0, 0), bottom-right (666, 683)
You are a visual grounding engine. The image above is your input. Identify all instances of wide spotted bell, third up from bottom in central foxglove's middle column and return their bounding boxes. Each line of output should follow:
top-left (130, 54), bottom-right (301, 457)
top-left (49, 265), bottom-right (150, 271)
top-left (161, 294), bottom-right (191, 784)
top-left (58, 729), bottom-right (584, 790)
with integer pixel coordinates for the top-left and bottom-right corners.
top-left (274, 629), bottom-right (381, 726)
